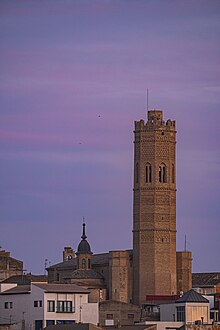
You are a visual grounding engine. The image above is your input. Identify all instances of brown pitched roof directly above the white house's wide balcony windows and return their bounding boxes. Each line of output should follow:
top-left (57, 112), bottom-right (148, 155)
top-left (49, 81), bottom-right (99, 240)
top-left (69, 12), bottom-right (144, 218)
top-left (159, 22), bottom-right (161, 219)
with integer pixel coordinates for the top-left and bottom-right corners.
top-left (34, 283), bottom-right (90, 293)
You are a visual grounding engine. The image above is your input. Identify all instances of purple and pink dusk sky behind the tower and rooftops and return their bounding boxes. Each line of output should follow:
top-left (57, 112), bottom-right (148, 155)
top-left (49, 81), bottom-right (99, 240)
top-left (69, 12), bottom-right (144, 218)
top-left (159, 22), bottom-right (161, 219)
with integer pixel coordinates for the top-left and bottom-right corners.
top-left (0, 0), bottom-right (220, 274)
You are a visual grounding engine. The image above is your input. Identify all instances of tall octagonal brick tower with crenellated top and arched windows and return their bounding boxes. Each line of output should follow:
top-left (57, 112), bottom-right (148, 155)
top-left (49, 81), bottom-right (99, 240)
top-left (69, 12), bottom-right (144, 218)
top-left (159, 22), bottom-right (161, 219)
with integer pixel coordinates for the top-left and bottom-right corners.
top-left (133, 110), bottom-right (176, 304)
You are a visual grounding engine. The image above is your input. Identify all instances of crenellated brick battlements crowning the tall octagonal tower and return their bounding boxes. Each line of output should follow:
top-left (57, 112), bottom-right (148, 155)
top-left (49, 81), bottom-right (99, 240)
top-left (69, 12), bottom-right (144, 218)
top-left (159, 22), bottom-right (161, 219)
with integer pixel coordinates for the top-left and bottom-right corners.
top-left (135, 110), bottom-right (176, 131)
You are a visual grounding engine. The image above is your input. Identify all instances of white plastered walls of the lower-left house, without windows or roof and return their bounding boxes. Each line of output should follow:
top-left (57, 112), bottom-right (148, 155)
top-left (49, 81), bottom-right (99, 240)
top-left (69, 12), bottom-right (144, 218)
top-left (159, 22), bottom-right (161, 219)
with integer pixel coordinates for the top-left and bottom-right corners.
top-left (0, 283), bottom-right (99, 330)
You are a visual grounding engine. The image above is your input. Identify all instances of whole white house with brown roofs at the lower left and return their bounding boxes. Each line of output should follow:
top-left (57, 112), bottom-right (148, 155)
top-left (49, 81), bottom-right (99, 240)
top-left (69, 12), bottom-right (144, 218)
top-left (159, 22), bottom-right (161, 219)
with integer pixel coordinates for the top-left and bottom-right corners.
top-left (0, 283), bottom-right (99, 330)
